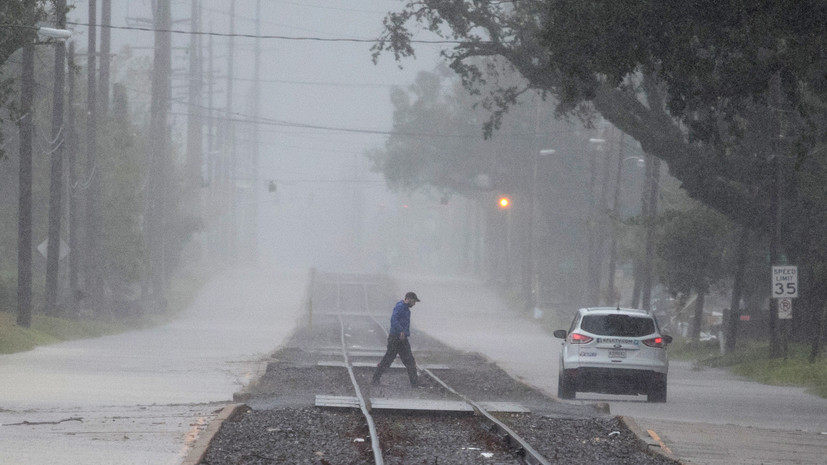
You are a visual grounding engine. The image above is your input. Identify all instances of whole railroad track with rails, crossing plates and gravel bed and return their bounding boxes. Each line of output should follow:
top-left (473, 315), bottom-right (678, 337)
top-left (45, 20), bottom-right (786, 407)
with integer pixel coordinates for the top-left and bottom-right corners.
top-left (199, 273), bottom-right (673, 465)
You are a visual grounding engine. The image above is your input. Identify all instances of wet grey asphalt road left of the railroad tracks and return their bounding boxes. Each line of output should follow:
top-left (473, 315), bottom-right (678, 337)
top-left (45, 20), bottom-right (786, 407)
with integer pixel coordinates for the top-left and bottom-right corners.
top-left (0, 269), bottom-right (307, 465)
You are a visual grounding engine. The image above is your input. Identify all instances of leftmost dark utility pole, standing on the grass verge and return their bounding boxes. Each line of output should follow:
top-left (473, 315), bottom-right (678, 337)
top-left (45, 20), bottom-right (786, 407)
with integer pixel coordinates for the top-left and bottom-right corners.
top-left (17, 2), bottom-right (35, 328)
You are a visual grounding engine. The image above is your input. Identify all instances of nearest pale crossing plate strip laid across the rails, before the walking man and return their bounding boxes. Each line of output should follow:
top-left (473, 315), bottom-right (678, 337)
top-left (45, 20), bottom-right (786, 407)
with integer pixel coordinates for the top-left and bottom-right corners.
top-left (316, 395), bottom-right (530, 413)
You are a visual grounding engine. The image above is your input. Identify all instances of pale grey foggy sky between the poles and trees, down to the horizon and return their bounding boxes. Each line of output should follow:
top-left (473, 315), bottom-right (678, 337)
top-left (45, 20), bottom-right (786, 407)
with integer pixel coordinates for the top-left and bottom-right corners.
top-left (68, 0), bottom-right (450, 271)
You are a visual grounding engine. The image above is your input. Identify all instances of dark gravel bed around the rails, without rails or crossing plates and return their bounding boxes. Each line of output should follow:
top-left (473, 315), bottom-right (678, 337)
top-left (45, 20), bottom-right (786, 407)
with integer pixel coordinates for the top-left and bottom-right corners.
top-left (201, 278), bottom-right (677, 465)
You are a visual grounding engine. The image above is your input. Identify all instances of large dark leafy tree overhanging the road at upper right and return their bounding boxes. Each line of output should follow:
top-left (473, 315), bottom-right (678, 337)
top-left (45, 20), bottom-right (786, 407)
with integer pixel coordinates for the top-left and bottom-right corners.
top-left (374, 0), bottom-right (827, 353)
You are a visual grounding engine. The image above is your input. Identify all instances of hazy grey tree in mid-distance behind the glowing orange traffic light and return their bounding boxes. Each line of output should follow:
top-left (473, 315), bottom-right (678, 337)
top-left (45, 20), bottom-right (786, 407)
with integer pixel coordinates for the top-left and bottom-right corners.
top-left (369, 65), bottom-right (644, 307)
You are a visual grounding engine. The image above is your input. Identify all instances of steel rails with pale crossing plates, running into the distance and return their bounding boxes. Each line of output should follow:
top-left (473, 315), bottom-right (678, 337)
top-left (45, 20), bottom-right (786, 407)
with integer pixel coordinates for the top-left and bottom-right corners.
top-left (311, 275), bottom-right (551, 465)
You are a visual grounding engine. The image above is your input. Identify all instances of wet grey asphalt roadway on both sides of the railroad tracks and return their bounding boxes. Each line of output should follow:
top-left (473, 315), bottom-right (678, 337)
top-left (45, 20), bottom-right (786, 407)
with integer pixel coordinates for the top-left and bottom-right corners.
top-left (0, 270), bottom-right (827, 465)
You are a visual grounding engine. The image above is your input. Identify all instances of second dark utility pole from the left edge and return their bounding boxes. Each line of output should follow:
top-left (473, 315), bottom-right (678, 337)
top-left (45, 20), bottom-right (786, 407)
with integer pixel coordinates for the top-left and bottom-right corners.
top-left (46, 0), bottom-right (66, 315)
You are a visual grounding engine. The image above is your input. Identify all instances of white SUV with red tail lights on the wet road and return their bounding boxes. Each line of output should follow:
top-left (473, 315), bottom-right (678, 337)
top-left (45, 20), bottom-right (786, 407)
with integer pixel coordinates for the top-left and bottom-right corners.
top-left (554, 307), bottom-right (672, 402)
